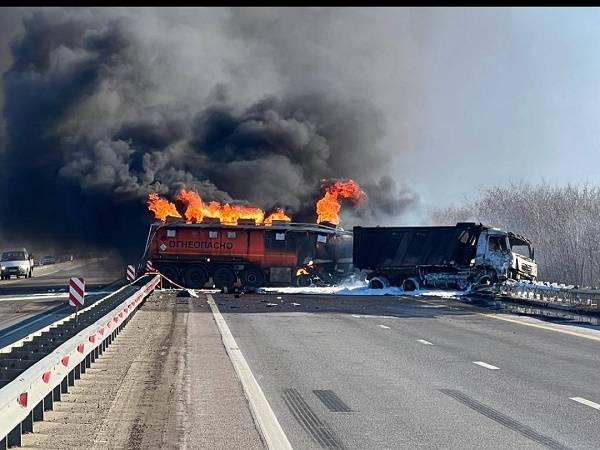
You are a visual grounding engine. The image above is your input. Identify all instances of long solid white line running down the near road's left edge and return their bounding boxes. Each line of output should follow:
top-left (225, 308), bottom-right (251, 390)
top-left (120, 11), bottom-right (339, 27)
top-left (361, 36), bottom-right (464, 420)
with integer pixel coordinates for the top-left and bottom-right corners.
top-left (206, 294), bottom-right (292, 450)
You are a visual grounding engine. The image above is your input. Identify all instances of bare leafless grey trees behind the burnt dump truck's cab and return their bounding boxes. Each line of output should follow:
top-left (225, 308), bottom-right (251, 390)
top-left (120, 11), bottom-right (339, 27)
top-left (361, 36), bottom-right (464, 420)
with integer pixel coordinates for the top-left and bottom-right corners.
top-left (430, 183), bottom-right (600, 286)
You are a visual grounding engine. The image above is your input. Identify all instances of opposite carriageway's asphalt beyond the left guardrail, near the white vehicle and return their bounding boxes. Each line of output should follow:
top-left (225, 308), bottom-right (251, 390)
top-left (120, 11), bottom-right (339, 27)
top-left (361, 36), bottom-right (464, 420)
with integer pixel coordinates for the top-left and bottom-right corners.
top-left (0, 259), bottom-right (124, 348)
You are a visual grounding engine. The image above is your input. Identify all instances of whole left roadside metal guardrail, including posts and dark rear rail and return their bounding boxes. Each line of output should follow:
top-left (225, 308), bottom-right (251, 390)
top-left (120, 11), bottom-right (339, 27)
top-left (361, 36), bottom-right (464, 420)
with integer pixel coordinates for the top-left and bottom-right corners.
top-left (0, 275), bottom-right (160, 450)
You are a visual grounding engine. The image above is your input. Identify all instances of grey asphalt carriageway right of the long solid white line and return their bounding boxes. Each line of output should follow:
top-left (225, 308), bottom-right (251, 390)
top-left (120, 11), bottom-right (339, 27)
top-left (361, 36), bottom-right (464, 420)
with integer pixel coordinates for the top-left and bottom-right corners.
top-left (214, 294), bottom-right (600, 449)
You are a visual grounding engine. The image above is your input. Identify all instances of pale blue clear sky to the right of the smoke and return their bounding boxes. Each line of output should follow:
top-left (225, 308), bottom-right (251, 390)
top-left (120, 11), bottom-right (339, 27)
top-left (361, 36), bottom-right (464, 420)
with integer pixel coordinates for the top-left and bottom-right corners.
top-left (360, 8), bottom-right (600, 204)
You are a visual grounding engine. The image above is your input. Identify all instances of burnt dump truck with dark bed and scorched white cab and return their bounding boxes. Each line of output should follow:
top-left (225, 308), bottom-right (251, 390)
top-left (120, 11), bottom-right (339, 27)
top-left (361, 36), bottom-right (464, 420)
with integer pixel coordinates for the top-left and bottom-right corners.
top-left (352, 222), bottom-right (537, 291)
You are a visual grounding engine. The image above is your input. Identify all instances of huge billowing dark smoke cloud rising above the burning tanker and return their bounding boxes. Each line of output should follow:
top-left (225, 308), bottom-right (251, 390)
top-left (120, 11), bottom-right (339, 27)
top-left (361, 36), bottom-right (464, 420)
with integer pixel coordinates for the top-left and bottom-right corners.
top-left (0, 10), bottom-right (417, 251)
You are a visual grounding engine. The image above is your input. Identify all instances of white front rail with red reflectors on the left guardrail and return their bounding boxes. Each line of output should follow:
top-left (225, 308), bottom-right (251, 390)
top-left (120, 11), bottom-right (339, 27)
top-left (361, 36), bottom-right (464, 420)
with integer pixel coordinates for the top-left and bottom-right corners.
top-left (0, 276), bottom-right (160, 443)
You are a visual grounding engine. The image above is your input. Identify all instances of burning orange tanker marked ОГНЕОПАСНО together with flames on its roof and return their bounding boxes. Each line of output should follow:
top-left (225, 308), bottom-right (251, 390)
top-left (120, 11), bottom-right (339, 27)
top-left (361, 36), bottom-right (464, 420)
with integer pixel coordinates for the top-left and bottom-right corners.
top-left (142, 180), bottom-right (366, 291)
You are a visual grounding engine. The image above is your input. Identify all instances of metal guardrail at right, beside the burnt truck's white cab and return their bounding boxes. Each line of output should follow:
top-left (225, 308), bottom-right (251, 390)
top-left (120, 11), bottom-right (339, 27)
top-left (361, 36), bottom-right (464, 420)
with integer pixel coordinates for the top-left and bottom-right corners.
top-left (499, 283), bottom-right (600, 312)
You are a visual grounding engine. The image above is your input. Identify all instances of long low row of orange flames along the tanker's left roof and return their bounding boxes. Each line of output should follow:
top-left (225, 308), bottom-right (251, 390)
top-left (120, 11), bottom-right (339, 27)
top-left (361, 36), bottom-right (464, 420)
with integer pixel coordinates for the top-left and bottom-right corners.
top-left (148, 189), bottom-right (291, 224)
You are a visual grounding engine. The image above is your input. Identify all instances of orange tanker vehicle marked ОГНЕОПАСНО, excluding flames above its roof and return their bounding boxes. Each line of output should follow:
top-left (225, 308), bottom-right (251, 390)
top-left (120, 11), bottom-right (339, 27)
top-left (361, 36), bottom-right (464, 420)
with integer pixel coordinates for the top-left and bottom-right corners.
top-left (142, 218), bottom-right (352, 291)
